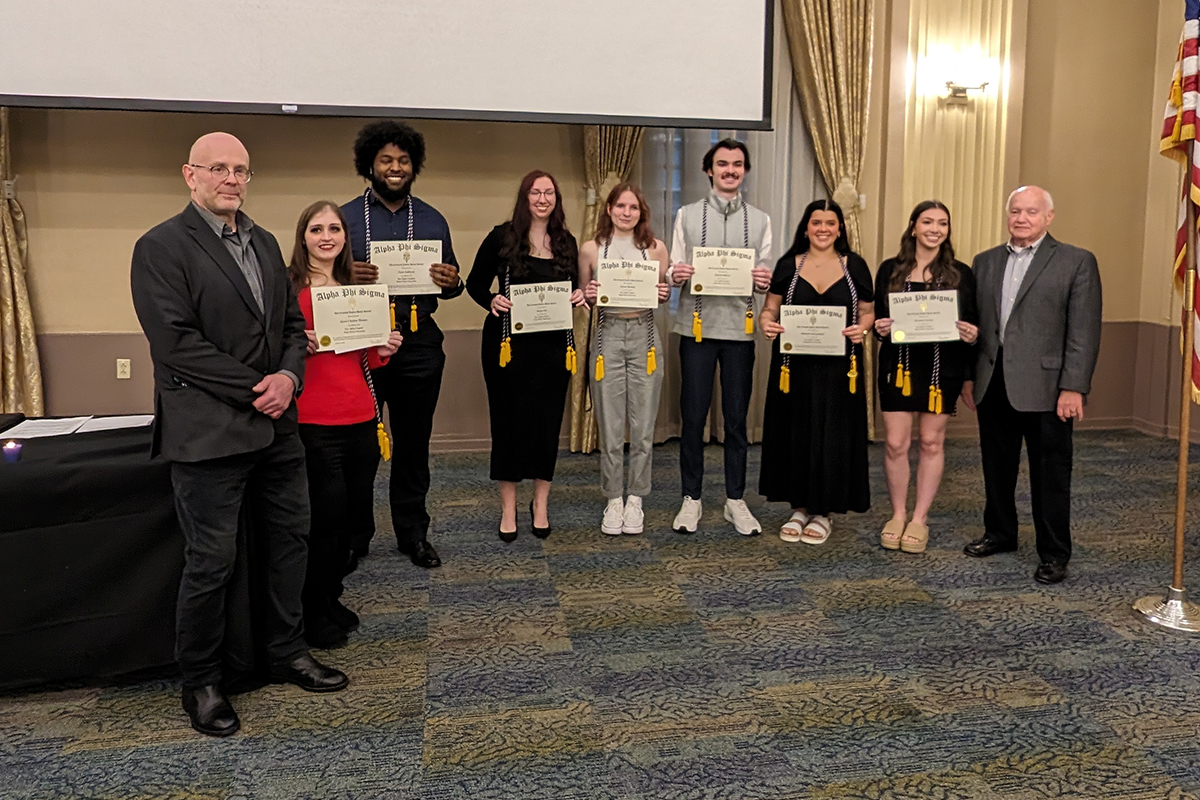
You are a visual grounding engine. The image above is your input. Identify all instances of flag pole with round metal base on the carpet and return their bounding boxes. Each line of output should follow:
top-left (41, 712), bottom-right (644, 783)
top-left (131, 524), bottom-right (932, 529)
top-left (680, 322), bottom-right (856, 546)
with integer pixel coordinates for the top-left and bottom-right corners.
top-left (1133, 140), bottom-right (1200, 633)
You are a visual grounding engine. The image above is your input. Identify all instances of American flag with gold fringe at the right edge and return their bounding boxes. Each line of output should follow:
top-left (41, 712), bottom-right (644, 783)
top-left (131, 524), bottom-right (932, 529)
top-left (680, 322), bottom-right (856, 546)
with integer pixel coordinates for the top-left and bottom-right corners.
top-left (1159, 0), bottom-right (1200, 403)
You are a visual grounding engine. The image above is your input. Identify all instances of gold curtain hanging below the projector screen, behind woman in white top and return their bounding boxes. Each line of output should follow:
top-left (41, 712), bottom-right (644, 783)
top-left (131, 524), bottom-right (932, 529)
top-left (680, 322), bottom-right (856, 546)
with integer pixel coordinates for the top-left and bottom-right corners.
top-left (570, 125), bottom-right (642, 452)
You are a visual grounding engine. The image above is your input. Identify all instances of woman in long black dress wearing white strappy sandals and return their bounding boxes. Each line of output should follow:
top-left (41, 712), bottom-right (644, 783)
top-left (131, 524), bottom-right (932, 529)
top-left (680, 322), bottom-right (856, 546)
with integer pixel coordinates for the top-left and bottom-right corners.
top-left (758, 200), bottom-right (875, 545)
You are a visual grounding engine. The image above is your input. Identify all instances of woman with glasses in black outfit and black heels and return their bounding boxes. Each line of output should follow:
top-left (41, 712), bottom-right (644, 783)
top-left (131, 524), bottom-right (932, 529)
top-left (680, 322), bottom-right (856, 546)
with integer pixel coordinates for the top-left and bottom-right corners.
top-left (467, 169), bottom-right (586, 542)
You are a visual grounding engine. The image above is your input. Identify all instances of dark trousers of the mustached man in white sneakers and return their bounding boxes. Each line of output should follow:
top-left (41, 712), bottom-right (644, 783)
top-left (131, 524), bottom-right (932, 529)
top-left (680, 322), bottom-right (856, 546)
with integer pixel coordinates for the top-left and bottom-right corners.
top-left (679, 336), bottom-right (755, 500)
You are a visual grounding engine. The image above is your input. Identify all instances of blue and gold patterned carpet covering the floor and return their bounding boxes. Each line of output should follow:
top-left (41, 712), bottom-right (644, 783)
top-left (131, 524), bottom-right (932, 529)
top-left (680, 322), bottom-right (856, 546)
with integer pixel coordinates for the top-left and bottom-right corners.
top-left (0, 432), bottom-right (1200, 800)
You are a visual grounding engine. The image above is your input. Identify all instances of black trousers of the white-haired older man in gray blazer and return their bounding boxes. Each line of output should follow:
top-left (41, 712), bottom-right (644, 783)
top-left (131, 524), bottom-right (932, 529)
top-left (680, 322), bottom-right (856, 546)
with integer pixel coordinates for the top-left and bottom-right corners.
top-left (978, 353), bottom-right (1073, 564)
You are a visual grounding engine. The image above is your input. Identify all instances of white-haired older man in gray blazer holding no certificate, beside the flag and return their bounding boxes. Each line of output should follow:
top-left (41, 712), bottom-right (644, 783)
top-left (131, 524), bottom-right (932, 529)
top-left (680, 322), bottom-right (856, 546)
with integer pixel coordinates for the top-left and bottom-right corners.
top-left (962, 186), bottom-right (1100, 583)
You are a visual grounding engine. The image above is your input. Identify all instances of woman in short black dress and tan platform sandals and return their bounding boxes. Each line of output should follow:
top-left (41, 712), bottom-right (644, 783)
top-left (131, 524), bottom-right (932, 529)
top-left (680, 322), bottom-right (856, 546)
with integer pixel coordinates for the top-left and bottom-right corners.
top-left (875, 200), bottom-right (979, 553)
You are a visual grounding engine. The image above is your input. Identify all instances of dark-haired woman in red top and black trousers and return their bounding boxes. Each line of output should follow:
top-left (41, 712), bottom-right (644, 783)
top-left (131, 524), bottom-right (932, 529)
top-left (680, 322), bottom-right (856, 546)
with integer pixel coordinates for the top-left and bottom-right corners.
top-left (288, 200), bottom-right (401, 648)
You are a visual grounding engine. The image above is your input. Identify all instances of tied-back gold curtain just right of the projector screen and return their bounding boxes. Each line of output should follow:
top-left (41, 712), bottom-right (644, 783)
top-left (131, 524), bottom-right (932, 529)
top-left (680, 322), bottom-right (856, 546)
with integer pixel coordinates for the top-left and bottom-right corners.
top-left (780, 0), bottom-right (875, 431)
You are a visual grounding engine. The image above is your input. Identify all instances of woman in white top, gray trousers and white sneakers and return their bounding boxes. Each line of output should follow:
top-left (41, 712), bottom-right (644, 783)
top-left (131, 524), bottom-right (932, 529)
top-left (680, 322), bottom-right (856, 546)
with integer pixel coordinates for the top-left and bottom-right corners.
top-left (580, 184), bottom-right (671, 535)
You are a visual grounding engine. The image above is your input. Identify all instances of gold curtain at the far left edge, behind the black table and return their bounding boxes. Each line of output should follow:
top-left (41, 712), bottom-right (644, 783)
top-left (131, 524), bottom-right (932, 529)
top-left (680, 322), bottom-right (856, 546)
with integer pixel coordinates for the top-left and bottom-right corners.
top-left (0, 108), bottom-right (46, 416)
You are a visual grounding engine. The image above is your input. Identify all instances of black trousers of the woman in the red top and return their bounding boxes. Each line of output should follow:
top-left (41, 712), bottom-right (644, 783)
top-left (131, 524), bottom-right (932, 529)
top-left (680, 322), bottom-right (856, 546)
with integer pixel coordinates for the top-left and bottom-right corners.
top-left (300, 420), bottom-right (379, 621)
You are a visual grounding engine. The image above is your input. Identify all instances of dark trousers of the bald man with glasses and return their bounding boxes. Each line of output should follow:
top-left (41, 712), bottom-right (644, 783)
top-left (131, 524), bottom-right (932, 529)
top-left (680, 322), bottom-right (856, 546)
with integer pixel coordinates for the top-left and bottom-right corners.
top-left (170, 433), bottom-right (308, 688)
